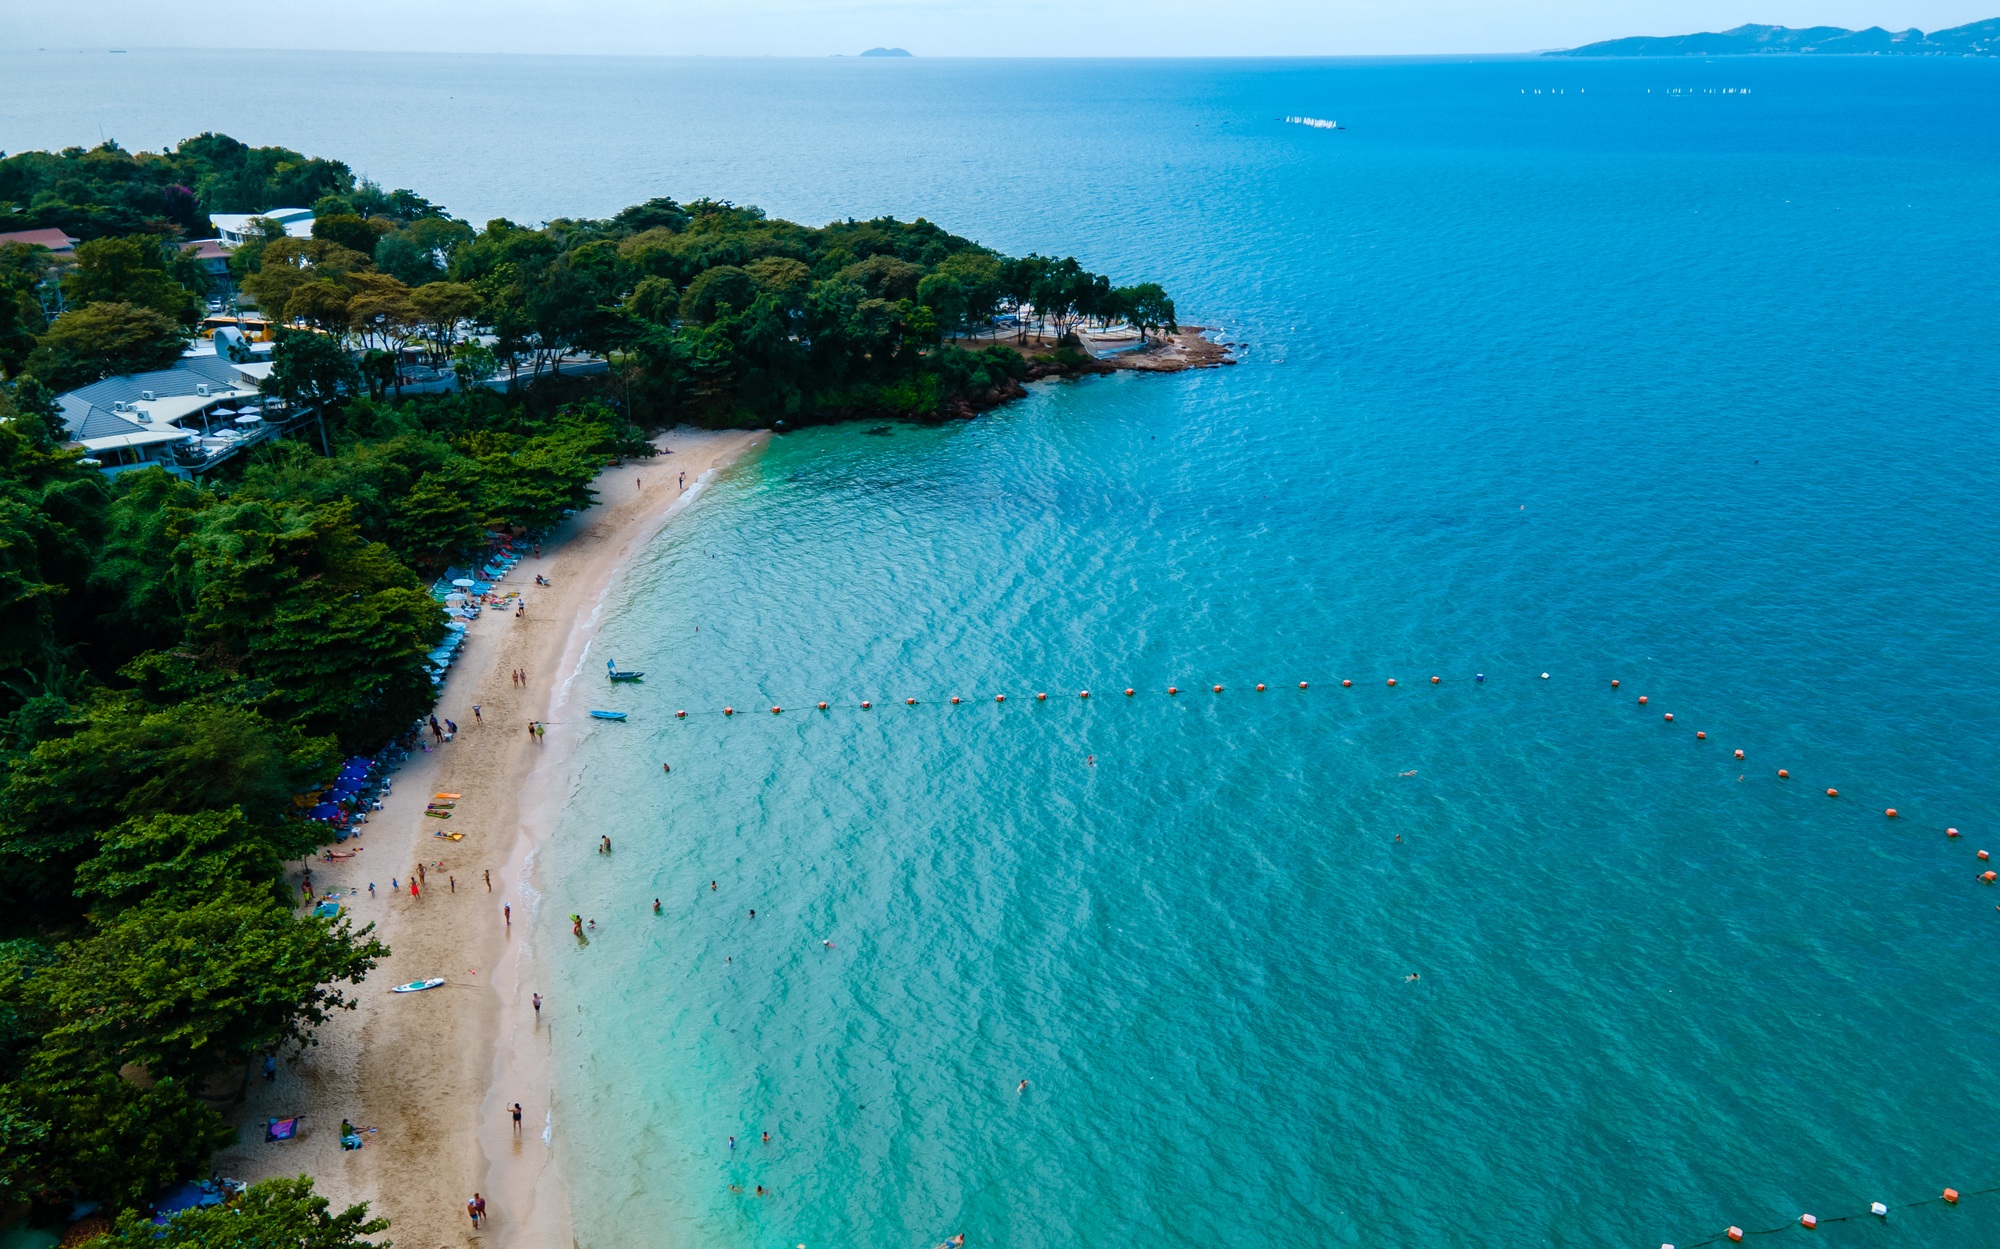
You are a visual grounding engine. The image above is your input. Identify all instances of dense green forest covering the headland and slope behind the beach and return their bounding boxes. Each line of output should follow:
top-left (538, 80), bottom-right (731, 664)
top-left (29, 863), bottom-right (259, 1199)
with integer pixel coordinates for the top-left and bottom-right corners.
top-left (0, 134), bottom-right (1174, 1245)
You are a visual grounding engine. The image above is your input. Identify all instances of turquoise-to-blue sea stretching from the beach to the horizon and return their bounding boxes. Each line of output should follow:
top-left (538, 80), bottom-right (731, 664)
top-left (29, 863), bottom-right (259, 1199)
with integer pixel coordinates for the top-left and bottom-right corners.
top-left (11, 52), bottom-right (2000, 1249)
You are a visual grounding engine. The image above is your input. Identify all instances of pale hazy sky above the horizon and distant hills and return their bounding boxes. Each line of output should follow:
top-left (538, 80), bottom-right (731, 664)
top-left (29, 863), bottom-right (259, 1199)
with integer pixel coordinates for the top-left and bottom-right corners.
top-left (0, 0), bottom-right (2000, 56)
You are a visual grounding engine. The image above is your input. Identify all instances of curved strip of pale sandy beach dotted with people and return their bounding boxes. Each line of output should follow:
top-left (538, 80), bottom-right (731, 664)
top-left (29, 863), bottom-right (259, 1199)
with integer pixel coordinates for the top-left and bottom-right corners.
top-left (214, 430), bottom-right (766, 1249)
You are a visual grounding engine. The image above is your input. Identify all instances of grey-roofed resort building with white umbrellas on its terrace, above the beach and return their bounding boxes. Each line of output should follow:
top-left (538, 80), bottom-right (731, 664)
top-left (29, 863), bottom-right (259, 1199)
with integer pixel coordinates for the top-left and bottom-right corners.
top-left (56, 354), bottom-right (298, 476)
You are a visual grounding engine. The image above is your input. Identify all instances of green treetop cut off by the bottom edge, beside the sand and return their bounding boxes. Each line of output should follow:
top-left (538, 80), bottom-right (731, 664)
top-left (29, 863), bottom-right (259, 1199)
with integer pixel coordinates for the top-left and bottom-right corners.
top-left (92, 1175), bottom-right (388, 1249)
